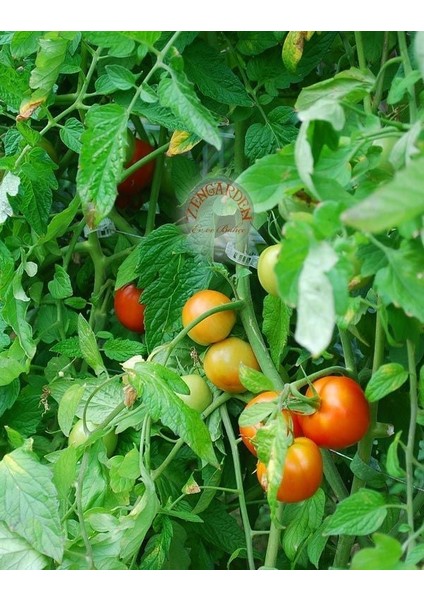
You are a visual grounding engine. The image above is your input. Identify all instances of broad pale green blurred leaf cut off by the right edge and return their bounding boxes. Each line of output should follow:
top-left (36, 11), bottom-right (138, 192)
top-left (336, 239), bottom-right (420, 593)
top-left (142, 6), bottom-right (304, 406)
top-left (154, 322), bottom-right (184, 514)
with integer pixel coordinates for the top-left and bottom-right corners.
top-left (342, 157), bottom-right (424, 233)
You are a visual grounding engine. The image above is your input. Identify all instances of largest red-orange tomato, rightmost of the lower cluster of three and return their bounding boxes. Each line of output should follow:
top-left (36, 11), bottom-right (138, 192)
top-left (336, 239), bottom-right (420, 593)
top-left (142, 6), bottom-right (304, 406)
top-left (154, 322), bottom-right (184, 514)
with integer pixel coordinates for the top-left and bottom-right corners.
top-left (299, 375), bottom-right (370, 448)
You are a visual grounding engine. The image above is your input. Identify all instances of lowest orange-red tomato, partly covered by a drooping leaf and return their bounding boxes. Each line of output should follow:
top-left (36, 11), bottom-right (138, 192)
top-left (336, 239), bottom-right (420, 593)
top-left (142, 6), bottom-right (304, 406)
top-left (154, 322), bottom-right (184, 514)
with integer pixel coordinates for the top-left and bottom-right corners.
top-left (256, 437), bottom-right (323, 502)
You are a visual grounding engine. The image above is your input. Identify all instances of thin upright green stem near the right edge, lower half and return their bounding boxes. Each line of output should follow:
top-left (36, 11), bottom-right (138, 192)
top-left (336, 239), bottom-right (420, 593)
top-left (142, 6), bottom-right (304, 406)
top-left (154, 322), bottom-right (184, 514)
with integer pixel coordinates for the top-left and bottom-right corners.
top-left (405, 340), bottom-right (418, 554)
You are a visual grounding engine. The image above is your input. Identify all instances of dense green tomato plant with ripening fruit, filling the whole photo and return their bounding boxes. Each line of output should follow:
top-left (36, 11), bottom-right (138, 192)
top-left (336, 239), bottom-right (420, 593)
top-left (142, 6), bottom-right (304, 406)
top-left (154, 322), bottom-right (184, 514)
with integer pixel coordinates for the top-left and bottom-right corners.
top-left (0, 30), bottom-right (424, 576)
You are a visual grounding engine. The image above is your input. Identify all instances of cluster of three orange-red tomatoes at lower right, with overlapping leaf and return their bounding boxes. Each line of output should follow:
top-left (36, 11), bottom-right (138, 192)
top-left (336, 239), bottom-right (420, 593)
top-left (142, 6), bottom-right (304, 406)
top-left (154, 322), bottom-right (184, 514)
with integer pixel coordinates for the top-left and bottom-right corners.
top-left (240, 375), bottom-right (370, 502)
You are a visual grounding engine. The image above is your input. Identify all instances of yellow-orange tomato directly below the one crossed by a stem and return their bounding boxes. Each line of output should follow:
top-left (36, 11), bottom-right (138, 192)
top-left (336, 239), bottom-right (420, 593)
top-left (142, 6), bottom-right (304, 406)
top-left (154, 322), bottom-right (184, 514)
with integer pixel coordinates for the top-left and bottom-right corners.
top-left (203, 337), bottom-right (260, 393)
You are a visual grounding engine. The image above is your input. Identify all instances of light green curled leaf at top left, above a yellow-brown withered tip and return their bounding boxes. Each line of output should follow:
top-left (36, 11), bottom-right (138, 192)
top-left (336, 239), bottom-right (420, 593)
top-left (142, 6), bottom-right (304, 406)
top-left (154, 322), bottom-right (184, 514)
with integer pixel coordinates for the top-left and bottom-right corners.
top-left (29, 32), bottom-right (69, 98)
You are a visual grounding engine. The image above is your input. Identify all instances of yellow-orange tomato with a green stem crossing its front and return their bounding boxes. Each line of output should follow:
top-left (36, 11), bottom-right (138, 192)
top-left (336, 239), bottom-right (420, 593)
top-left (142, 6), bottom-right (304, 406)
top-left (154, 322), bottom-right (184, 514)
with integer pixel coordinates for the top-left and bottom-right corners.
top-left (182, 290), bottom-right (236, 346)
